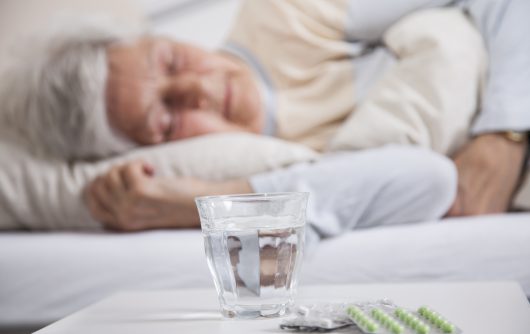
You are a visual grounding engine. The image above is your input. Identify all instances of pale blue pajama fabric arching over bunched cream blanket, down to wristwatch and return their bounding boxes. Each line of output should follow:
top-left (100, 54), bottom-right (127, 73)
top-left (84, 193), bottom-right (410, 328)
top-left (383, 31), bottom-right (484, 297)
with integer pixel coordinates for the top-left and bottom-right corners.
top-left (346, 0), bottom-right (530, 134)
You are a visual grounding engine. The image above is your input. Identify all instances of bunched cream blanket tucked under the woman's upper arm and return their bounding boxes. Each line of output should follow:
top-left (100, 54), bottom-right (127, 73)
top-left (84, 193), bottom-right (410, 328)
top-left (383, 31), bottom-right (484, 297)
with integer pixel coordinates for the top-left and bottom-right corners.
top-left (328, 8), bottom-right (487, 155)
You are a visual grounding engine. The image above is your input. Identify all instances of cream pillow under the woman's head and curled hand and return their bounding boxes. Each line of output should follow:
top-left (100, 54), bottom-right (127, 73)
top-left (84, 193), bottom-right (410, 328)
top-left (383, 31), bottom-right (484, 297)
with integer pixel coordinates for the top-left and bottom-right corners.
top-left (0, 133), bottom-right (317, 229)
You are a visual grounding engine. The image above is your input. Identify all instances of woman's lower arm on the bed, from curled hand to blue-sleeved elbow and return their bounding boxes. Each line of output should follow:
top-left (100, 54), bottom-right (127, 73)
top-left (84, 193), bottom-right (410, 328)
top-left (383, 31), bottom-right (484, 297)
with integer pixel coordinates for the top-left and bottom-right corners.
top-left (83, 146), bottom-right (456, 236)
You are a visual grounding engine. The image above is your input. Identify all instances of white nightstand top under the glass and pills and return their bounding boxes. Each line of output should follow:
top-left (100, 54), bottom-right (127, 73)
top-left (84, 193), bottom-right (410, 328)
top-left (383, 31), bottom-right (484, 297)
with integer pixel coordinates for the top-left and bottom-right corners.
top-left (37, 282), bottom-right (530, 334)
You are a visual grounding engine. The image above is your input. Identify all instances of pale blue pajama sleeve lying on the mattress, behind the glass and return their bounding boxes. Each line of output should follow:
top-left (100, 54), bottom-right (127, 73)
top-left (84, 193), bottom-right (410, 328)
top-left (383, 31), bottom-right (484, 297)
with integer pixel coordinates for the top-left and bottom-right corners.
top-left (249, 145), bottom-right (457, 237)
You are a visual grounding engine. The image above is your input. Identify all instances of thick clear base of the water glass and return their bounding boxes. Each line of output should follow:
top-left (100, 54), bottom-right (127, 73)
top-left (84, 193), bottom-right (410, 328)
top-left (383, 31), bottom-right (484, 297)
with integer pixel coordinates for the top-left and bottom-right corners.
top-left (221, 303), bottom-right (291, 319)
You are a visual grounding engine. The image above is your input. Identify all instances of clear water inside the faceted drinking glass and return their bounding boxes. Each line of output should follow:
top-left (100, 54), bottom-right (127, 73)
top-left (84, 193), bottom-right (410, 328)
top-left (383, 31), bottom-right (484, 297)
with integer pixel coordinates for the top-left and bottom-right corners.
top-left (203, 216), bottom-right (305, 318)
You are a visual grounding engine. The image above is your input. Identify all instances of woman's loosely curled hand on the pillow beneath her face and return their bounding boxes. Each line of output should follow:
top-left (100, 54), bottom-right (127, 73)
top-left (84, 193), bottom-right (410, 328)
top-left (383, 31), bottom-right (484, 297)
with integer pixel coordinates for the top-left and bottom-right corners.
top-left (85, 161), bottom-right (204, 231)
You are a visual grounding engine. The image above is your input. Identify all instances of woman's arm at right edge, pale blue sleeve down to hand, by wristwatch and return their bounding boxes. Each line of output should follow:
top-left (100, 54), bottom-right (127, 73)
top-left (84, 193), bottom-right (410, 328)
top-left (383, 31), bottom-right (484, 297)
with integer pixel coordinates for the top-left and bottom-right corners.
top-left (450, 0), bottom-right (530, 216)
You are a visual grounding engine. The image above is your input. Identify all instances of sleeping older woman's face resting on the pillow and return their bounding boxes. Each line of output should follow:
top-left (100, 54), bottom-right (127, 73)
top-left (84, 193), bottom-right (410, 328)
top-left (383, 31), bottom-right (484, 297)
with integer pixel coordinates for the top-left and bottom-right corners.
top-left (106, 37), bottom-right (264, 145)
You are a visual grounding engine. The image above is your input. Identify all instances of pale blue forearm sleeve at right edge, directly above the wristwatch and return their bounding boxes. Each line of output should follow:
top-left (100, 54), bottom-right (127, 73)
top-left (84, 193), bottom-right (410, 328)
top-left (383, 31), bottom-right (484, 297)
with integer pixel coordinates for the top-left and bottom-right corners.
top-left (466, 0), bottom-right (530, 134)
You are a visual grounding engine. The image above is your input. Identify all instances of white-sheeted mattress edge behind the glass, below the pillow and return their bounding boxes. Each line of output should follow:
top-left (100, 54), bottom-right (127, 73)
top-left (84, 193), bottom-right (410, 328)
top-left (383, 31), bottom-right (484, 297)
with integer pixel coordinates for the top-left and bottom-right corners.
top-left (0, 214), bottom-right (530, 328)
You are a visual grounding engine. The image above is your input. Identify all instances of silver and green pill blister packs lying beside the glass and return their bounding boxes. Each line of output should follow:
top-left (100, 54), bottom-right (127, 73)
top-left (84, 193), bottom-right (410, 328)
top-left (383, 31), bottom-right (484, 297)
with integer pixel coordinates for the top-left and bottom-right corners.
top-left (280, 300), bottom-right (462, 334)
